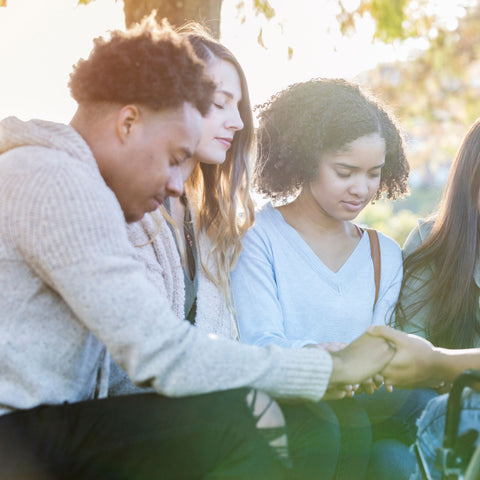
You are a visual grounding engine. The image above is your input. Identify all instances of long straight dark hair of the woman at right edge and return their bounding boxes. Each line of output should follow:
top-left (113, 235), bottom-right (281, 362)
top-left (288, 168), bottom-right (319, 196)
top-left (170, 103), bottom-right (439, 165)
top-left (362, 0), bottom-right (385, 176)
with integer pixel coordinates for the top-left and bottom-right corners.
top-left (395, 119), bottom-right (480, 348)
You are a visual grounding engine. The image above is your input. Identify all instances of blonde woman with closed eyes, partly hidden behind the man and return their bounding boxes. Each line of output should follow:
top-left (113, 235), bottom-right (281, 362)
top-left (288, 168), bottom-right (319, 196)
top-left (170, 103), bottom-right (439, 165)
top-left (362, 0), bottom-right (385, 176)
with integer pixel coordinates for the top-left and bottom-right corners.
top-left (124, 25), bottom-right (253, 338)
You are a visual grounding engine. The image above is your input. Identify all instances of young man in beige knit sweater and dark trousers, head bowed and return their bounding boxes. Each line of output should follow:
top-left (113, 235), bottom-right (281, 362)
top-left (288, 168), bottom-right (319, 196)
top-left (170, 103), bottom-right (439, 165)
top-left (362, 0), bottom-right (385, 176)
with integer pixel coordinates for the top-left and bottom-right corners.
top-left (0, 20), bottom-right (398, 480)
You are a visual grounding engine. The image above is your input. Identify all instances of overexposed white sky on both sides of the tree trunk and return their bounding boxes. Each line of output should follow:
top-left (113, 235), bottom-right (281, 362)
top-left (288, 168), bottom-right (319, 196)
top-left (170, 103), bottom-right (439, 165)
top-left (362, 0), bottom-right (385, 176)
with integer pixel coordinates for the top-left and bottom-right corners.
top-left (0, 0), bottom-right (475, 122)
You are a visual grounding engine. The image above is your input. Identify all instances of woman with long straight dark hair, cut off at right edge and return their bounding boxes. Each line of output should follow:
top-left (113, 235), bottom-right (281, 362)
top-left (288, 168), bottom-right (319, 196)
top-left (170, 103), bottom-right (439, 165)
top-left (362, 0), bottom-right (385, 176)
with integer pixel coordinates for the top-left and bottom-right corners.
top-left (377, 119), bottom-right (480, 479)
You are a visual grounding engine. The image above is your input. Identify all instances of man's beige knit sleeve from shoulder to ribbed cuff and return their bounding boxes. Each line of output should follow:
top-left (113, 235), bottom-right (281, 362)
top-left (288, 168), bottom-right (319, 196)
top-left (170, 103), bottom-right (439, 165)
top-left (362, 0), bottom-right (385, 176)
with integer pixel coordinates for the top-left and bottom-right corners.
top-left (8, 154), bottom-right (332, 400)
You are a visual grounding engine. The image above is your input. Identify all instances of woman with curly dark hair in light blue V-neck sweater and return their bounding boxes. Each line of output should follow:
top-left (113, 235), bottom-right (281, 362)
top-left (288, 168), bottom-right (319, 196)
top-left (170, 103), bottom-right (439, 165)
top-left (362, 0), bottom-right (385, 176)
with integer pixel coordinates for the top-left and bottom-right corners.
top-left (232, 79), bottom-right (435, 478)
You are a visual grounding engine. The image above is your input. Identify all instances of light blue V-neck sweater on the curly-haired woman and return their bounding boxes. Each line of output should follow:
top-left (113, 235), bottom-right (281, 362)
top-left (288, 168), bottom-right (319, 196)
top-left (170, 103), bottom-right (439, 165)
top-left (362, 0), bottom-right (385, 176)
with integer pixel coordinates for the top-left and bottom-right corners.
top-left (232, 204), bottom-right (403, 348)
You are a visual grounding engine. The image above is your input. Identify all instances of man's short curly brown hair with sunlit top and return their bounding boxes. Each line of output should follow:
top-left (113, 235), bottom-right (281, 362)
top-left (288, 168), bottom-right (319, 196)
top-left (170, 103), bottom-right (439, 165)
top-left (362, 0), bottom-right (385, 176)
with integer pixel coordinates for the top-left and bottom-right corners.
top-left (69, 16), bottom-right (215, 115)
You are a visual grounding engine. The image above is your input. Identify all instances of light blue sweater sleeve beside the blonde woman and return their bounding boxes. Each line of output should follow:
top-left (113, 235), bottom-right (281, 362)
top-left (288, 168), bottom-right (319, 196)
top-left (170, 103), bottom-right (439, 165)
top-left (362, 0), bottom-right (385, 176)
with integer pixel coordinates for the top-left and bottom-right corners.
top-left (232, 219), bottom-right (318, 348)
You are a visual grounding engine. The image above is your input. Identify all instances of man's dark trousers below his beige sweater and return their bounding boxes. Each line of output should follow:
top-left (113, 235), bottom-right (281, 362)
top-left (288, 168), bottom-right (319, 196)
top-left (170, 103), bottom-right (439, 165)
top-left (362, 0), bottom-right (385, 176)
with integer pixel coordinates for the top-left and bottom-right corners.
top-left (0, 390), bottom-right (285, 480)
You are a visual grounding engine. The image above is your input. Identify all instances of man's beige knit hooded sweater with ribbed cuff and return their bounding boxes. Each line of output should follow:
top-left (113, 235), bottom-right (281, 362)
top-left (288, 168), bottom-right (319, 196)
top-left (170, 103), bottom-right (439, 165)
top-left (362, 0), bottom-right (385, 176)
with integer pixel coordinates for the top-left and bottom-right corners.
top-left (0, 117), bottom-right (332, 414)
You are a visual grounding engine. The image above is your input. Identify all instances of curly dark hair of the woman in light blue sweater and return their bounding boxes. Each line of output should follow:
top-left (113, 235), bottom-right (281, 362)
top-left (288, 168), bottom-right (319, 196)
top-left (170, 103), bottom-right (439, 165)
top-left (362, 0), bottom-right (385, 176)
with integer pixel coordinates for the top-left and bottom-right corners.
top-left (254, 78), bottom-right (409, 200)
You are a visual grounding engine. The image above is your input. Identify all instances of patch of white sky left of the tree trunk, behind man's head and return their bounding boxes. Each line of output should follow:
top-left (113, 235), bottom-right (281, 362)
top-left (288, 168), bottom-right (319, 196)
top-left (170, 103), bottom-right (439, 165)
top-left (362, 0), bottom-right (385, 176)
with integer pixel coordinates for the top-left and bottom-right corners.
top-left (0, 0), bottom-right (124, 121)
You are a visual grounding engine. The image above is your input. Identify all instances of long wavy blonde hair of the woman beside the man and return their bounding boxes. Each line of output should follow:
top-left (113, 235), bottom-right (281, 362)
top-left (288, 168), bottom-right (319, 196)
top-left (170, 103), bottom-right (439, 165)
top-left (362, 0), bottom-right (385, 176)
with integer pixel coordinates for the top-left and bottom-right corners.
top-left (179, 23), bottom-right (254, 312)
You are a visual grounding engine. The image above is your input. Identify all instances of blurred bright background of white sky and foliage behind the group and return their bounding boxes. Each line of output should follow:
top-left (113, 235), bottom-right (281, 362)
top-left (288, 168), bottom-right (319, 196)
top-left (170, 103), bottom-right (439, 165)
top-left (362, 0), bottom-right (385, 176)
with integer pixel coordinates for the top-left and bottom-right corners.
top-left (0, 0), bottom-right (480, 245)
